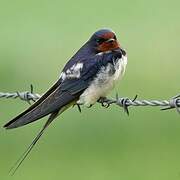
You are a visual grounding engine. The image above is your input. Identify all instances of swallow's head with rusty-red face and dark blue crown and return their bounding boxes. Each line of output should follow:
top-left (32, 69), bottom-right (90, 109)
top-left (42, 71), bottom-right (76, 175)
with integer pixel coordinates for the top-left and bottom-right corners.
top-left (90, 29), bottom-right (120, 53)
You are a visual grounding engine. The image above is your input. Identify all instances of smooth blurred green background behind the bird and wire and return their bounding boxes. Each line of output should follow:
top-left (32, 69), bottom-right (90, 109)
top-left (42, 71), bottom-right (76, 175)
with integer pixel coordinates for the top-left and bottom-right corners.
top-left (0, 0), bottom-right (180, 180)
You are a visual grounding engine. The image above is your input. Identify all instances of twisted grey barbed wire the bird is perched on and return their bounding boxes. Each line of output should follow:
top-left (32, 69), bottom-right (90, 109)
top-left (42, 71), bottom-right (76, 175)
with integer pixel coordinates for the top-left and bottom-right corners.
top-left (0, 85), bottom-right (180, 114)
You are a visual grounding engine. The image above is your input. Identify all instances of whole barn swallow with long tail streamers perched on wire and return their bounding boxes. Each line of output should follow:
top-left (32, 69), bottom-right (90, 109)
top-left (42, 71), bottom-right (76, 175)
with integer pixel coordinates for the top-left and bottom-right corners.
top-left (4, 29), bottom-right (127, 172)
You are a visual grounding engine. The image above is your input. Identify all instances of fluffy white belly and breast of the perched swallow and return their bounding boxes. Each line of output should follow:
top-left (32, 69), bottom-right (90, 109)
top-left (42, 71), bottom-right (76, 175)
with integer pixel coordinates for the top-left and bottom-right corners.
top-left (77, 56), bottom-right (127, 106)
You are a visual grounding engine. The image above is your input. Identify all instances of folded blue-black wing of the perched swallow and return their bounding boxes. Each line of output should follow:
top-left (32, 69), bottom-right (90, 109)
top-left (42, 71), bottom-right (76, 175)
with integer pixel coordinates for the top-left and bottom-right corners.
top-left (4, 48), bottom-right (121, 129)
